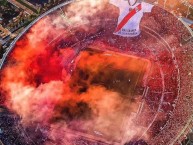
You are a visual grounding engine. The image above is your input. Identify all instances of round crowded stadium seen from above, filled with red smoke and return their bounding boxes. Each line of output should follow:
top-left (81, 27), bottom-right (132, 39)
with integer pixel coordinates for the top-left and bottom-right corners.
top-left (0, 0), bottom-right (193, 145)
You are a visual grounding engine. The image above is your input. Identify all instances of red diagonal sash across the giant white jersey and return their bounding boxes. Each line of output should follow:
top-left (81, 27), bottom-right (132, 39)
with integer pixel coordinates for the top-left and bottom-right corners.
top-left (115, 4), bottom-right (141, 33)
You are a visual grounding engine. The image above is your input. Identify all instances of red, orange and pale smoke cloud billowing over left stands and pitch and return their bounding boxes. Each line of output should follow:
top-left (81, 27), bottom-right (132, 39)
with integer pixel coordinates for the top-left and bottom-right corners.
top-left (1, 0), bottom-right (176, 142)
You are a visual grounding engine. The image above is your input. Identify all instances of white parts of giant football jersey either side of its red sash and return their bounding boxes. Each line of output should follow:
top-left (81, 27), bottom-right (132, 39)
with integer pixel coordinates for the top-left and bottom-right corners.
top-left (110, 0), bottom-right (153, 37)
